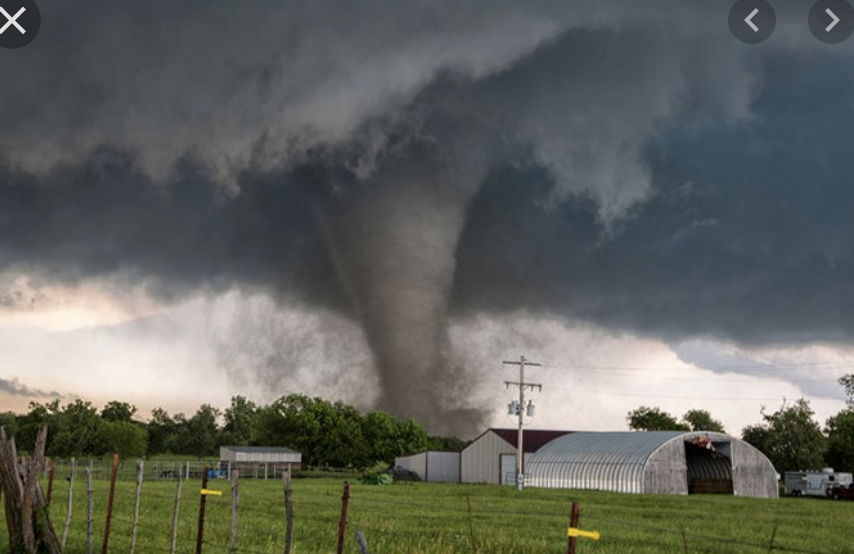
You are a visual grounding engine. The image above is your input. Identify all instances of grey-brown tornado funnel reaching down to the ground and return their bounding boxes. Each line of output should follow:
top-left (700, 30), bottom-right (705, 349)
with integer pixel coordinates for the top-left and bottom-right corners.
top-left (326, 117), bottom-right (491, 434)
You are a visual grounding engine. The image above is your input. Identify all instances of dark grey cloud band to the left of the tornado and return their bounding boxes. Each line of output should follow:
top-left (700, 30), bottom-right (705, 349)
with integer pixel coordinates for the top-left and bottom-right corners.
top-left (0, 148), bottom-right (338, 303)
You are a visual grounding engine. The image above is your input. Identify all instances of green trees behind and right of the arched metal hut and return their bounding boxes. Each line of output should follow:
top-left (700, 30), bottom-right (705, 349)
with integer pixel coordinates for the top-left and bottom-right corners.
top-left (626, 375), bottom-right (854, 472)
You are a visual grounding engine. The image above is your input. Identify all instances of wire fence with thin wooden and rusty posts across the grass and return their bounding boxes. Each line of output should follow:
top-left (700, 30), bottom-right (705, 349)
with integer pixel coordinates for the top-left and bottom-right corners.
top-left (3, 454), bottom-right (854, 554)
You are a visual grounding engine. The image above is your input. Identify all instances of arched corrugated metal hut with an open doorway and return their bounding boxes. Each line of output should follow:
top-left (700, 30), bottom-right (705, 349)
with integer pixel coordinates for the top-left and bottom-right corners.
top-left (526, 431), bottom-right (779, 498)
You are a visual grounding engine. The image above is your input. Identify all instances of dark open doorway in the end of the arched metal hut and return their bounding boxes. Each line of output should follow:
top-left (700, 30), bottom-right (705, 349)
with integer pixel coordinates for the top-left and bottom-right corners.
top-left (685, 438), bottom-right (733, 494)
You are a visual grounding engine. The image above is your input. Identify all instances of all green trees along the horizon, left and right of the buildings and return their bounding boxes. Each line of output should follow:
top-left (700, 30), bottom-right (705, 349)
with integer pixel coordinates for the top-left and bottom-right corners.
top-left (0, 375), bottom-right (854, 472)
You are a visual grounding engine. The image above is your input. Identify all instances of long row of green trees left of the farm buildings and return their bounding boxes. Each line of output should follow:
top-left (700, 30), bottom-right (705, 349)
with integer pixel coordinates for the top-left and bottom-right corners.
top-left (0, 394), bottom-right (465, 469)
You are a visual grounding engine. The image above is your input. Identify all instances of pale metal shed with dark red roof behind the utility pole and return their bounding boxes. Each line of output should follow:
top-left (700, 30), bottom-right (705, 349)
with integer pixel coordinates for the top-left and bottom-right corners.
top-left (460, 428), bottom-right (571, 485)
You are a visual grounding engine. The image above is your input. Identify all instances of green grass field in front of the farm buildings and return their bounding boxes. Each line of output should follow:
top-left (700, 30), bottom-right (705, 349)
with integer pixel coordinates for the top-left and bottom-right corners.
top-left (0, 477), bottom-right (854, 554)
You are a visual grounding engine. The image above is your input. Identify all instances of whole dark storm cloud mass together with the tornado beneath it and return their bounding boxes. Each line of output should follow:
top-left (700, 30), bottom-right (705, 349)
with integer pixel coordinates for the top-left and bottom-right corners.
top-left (0, 0), bottom-right (852, 431)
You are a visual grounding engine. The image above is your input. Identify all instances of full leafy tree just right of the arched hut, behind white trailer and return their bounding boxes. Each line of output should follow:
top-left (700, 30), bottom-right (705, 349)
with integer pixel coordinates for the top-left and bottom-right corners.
top-left (742, 398), bottom-right (826, 472)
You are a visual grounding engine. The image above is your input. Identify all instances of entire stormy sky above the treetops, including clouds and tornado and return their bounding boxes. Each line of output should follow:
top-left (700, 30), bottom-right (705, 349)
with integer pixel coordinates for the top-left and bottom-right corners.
top-left (0, 0), bottom-right (854, 434)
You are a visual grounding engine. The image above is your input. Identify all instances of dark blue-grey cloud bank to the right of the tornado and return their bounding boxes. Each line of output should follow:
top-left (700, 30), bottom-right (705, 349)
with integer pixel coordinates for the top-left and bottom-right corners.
top-left (455, 52), bottom-right (854, 344)
